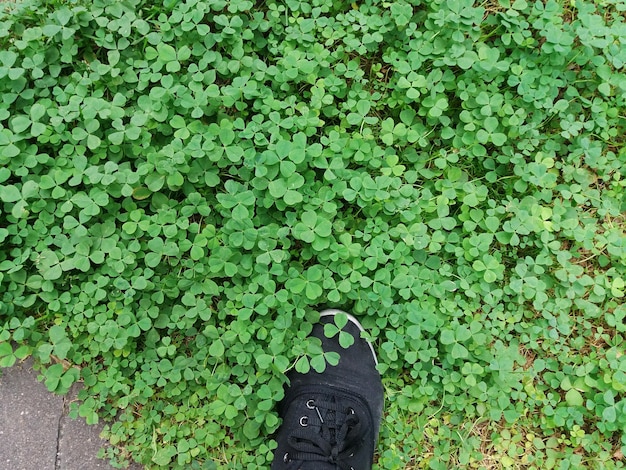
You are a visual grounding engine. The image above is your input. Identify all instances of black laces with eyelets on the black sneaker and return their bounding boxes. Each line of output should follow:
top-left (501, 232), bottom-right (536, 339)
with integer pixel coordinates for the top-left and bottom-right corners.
top-left (285, 397), bottom-right (363, 470)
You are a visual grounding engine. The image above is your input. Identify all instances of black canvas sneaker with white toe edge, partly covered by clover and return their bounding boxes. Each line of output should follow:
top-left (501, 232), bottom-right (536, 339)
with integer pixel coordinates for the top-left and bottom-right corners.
top-left (272, 310), bottom-right (383, 470)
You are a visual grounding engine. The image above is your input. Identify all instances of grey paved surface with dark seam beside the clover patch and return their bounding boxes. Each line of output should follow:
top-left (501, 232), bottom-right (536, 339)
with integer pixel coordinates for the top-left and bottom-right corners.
top-left (0, 360), bottom-right (141, 470)
